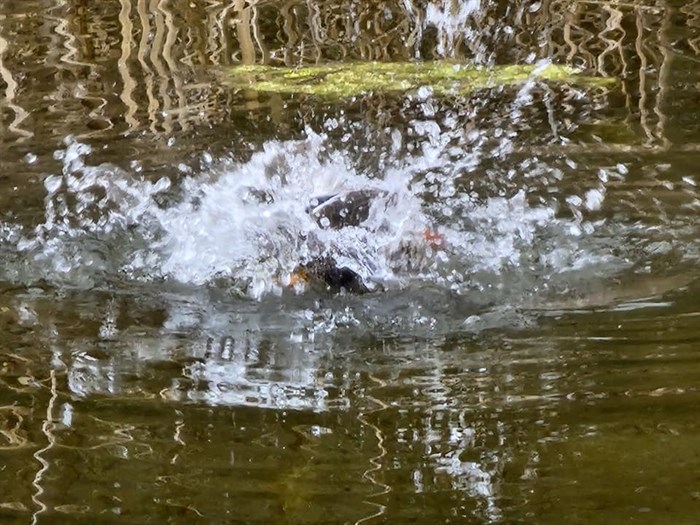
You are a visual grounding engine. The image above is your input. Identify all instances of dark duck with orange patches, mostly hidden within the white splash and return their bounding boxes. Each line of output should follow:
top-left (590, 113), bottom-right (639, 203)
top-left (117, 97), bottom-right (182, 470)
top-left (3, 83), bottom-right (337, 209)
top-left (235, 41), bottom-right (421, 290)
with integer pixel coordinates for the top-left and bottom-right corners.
top-left (290, 188), bottom-right (444, 294)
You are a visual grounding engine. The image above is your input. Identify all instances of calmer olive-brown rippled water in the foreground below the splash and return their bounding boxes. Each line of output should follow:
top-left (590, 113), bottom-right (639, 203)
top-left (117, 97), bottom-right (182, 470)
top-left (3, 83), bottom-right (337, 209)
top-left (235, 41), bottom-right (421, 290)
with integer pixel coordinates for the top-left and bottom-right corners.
top-left (2, 285), bottom-right (698, 523)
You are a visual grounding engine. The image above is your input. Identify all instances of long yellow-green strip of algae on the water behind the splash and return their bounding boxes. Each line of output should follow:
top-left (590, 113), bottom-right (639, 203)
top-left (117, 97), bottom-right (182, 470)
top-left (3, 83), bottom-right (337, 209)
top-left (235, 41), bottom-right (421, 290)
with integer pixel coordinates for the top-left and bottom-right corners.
top-left (226, 61), bottom-right (616, 99)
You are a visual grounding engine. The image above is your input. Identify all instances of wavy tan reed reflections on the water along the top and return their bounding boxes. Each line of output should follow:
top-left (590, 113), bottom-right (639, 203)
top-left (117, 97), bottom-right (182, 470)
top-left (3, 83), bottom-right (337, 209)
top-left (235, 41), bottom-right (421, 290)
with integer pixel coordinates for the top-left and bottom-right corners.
top-left (0, 0), bottom-right (697, 146)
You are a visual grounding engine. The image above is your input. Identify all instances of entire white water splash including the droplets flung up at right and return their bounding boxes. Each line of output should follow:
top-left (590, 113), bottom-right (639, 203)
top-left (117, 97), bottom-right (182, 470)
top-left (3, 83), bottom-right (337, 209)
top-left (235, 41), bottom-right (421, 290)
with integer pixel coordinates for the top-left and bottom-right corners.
top-left (0, 89), bottom-right (695, 330)
